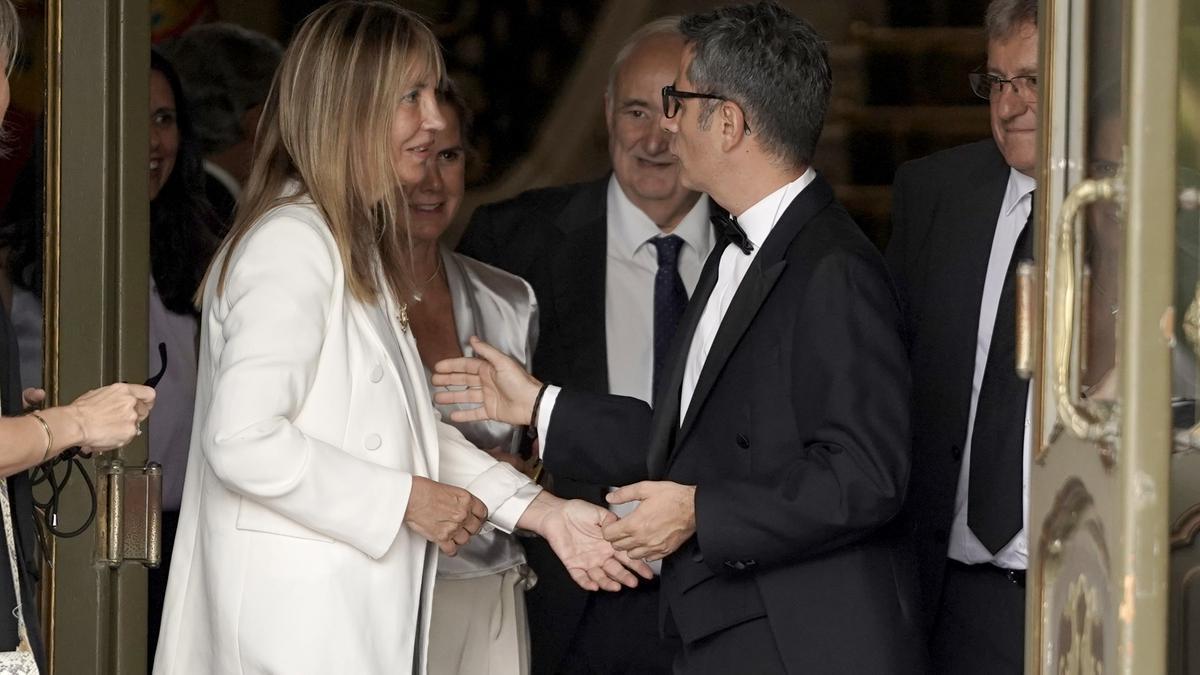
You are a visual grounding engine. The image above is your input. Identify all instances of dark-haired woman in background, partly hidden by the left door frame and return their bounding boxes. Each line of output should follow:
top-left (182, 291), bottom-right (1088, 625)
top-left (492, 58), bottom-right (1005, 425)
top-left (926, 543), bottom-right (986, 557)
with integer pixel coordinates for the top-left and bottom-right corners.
top-left (148, 52), bottom-right (221, 663)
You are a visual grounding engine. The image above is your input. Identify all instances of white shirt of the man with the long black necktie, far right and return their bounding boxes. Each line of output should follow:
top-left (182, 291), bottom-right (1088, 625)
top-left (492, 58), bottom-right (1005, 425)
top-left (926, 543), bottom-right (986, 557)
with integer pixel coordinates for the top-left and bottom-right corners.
top-left (949, 169), bottom-right (1036, 569)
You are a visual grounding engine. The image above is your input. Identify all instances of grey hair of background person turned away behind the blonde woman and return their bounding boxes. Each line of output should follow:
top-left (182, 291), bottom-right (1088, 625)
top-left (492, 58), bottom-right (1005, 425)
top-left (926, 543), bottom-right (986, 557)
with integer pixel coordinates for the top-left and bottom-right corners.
top-left (164, 22), bottom-right (283, 154)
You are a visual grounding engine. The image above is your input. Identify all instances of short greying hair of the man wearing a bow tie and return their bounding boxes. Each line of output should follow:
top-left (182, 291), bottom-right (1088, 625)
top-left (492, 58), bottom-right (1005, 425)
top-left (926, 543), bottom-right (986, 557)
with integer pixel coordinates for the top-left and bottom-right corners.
top-left (679, 1), bottom-right (833, 167)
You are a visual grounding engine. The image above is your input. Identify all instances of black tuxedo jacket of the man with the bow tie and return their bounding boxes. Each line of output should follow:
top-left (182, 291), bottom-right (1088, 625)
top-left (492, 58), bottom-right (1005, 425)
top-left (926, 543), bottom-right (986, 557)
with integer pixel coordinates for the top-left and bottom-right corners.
top-left (545, 177), bottom-right (923, 673)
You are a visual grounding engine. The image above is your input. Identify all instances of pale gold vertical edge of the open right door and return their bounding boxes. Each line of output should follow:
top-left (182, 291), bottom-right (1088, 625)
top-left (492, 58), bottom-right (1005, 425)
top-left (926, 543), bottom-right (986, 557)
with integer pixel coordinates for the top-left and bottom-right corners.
top-left (1115, 0), bottom-right (1181, 674)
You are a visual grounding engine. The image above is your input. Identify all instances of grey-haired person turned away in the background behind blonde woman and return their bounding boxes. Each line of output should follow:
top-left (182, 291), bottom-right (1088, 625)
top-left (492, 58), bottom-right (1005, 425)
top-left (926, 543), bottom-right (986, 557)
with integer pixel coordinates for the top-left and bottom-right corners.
top-left (163, 22), bottom-right (283, 229)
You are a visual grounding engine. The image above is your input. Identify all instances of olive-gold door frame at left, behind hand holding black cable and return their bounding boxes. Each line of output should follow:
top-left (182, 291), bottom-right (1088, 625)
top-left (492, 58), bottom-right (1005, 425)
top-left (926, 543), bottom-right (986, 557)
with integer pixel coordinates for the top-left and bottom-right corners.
top-left (42, 0), bottom-right (150, 674)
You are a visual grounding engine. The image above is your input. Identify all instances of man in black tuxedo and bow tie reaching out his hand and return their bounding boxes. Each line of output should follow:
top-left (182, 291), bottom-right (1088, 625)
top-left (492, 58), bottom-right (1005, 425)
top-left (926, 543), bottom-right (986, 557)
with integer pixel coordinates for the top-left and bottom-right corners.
top-left (436, 2), bottom-right (923, 674)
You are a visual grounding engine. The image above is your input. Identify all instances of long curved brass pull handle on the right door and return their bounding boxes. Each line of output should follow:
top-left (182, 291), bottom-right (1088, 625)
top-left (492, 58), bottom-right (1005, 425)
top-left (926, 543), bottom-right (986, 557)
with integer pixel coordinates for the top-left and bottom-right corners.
top-left (1051, 178), bottom-right (1121, 447)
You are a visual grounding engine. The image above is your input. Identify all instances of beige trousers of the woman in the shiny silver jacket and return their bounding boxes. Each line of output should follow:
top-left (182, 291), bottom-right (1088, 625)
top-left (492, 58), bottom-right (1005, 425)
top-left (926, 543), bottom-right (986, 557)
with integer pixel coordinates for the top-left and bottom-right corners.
top-left (428, 565), bottom-right (529, 675)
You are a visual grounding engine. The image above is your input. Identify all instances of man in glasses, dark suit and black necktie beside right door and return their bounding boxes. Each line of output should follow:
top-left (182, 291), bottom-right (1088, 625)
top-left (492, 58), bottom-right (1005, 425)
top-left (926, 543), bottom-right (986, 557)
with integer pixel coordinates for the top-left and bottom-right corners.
top-left (887, 0), bottom-right (1038, 674)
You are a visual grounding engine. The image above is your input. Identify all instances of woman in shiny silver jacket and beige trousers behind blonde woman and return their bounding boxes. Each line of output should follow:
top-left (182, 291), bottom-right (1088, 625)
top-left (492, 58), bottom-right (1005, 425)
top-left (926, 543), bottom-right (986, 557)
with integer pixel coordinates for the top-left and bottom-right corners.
top-left (408, 83), bottom-right (538, 675)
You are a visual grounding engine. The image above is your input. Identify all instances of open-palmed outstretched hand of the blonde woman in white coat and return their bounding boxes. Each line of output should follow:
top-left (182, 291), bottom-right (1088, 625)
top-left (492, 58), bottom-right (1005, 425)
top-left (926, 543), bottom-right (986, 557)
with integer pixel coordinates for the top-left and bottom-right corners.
top-left (517, 492), bottom-right (654, 591)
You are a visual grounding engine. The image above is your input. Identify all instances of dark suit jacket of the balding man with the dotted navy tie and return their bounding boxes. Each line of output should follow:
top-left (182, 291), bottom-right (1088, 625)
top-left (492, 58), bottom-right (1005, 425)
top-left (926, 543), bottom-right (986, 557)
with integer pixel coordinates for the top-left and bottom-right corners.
top-left (458, 177), bottom-right (628, 675)
